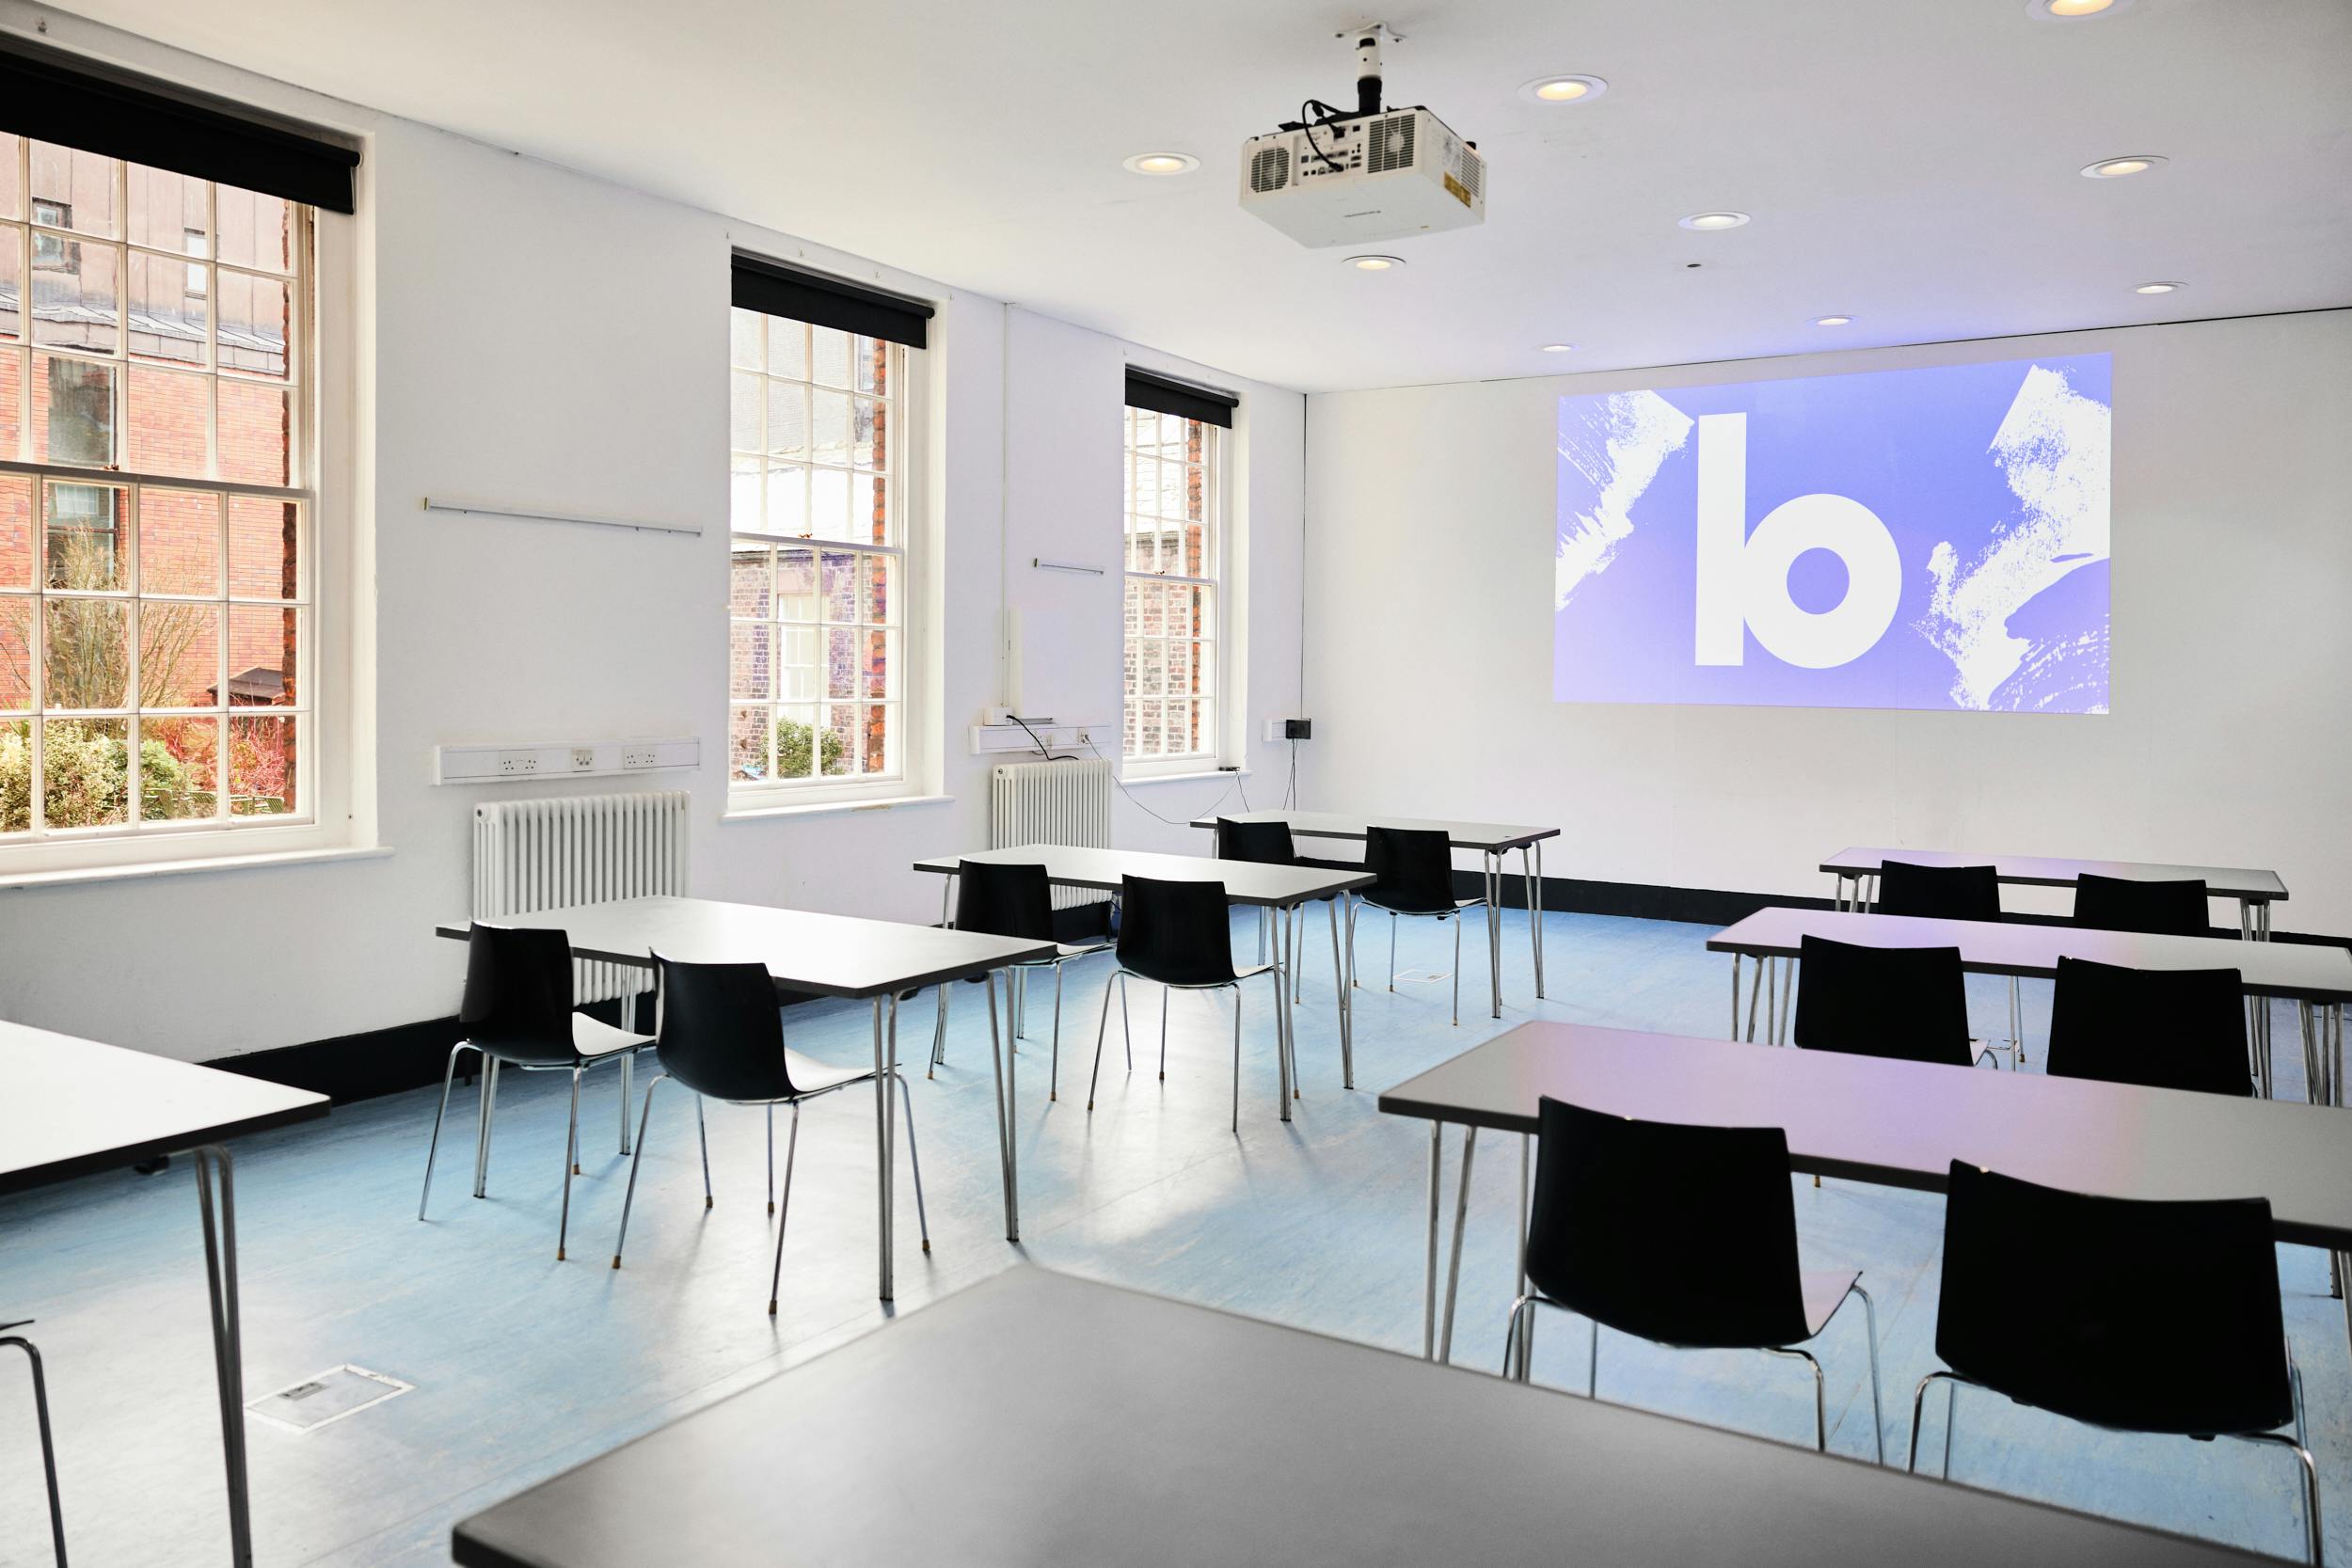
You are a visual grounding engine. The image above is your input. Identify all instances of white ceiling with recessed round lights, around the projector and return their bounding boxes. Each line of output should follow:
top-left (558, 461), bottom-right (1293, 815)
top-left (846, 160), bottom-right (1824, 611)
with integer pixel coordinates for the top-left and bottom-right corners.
top-left (37, 0), bottom-right (2352, 390)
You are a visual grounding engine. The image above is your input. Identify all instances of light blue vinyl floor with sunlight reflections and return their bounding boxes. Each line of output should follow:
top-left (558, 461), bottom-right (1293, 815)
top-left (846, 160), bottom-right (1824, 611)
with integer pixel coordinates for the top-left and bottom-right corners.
top-left (0, 912), bottom-right (2352, 1568)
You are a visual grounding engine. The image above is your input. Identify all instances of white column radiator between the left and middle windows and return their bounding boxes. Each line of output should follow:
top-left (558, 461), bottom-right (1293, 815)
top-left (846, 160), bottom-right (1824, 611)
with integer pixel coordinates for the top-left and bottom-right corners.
top-left (473, 790), bottom-right (691, 1002)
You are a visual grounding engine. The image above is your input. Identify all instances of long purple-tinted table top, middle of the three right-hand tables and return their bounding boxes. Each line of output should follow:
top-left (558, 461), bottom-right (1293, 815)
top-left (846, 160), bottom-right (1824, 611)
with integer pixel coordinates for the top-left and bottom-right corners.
top-left (1708, 905), bottom-right (2352, 1002)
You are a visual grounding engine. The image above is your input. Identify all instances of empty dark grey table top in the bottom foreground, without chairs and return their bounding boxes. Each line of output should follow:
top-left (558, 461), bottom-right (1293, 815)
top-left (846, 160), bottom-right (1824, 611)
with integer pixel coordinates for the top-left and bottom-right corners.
top-left (454, 1267), bottom-right (2267, 1568)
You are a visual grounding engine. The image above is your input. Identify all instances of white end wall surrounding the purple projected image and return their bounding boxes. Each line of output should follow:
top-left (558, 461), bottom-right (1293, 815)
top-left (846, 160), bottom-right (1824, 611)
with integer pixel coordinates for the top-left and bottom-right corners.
top-left (1303, 310), bottom-right (2352, 933)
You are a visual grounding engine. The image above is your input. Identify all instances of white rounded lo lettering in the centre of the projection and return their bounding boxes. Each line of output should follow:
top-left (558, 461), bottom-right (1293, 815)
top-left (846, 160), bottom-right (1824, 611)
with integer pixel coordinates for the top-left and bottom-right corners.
top-left (1698, 414), bottom-right (1903, 670)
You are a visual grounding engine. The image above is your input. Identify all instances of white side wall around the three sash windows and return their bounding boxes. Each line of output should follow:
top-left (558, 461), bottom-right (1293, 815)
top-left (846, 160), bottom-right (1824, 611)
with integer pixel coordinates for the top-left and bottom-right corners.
top-left (0, 0), bottom-right (1306, 1060)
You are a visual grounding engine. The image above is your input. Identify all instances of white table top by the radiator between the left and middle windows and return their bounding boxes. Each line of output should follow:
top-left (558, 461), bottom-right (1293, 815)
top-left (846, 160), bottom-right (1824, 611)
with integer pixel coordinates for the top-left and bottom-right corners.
top-left (436, 898), bottom-right (1057, 997)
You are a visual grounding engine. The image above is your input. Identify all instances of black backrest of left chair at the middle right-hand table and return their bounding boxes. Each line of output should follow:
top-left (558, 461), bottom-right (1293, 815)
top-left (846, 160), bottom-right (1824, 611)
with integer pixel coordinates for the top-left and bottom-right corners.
top-left (1790, 936), bottom-right (1976, 1068)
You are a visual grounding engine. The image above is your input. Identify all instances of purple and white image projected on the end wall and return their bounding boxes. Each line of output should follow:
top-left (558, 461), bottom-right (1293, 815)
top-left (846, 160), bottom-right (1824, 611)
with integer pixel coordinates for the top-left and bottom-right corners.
top-left (1552, 355), bottom-right (2110, 712)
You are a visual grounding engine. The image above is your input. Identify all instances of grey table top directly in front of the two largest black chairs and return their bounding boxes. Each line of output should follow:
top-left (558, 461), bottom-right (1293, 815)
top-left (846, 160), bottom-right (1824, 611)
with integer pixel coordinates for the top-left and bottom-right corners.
top-left (1381, 1022), bottom-right (2352, 1259)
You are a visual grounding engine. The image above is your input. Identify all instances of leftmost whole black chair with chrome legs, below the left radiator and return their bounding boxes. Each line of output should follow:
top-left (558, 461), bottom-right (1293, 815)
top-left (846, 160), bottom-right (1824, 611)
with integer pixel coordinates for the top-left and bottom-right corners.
top-left (417, 922), bottom-right (654, 1262)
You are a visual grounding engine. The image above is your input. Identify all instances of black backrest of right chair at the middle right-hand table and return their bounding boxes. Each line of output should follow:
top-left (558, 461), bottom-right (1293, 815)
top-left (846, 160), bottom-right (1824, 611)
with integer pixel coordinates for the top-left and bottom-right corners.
top-left (2044, 959), bottom-right (2253, 1096)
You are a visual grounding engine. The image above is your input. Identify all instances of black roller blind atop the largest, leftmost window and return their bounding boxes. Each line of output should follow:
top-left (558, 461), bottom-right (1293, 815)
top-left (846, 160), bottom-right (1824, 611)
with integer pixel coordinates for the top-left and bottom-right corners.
top-left (0, 38), bottom-right (360, 212)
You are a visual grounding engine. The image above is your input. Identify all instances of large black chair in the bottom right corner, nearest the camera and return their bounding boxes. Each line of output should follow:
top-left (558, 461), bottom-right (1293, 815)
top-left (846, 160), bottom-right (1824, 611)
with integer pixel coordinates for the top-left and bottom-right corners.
top-left (1910, 1159), bottom-right (2322, 1563)
